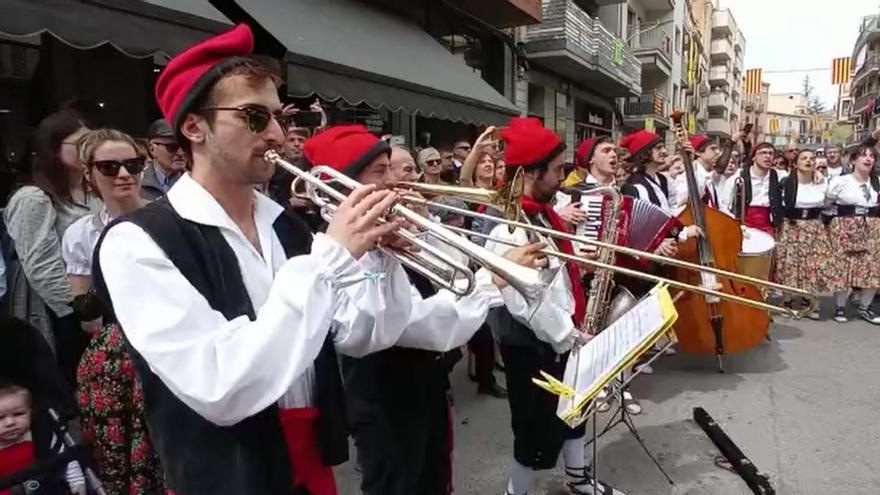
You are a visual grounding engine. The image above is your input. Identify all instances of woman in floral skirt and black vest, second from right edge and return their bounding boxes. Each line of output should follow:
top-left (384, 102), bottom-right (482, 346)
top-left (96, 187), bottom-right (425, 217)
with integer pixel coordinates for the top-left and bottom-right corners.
top-left (775, 149), bottom-right (832, 320)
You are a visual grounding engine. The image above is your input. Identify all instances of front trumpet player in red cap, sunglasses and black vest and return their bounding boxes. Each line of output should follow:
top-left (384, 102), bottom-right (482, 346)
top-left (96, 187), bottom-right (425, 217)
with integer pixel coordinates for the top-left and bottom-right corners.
top-left (94, 24), bottom-right (540, 495)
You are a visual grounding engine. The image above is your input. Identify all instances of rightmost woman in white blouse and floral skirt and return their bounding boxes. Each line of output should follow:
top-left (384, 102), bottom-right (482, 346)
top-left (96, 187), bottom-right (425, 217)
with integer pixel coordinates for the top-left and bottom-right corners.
top-left (825, 144), bottom-right (880, 325)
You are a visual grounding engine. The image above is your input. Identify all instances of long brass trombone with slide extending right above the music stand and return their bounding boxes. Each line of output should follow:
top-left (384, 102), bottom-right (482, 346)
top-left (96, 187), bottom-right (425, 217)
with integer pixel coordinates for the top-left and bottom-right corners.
top-left (397, 182), bottom-right (818, 318)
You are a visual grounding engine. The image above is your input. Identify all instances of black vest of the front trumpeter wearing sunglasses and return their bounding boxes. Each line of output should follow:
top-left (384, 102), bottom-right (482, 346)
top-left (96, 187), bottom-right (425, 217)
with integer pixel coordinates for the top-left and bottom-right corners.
top-left (93, 197), bottom-right (348, 495)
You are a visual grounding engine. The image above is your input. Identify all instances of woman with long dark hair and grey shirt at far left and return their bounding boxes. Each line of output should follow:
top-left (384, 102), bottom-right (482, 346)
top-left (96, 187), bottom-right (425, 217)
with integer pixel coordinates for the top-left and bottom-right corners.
top-left (4, 111), bottom-right (101, 384)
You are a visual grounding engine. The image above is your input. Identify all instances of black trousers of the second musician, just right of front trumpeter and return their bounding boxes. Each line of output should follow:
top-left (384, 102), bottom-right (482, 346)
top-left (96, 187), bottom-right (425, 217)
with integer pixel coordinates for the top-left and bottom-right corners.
top-left (348, 390), bottom-right (452, 495)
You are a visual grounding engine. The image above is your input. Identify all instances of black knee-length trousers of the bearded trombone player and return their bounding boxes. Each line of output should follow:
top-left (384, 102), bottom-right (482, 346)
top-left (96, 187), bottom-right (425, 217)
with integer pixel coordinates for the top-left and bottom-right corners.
top-left (501, 344), bottom-right (585, 469)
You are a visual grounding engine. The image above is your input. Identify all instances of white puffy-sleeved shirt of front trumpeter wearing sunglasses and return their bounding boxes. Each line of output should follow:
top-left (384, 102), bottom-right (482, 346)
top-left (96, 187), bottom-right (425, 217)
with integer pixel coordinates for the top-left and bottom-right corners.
top-left (98, 175), bottom-right (501, 425)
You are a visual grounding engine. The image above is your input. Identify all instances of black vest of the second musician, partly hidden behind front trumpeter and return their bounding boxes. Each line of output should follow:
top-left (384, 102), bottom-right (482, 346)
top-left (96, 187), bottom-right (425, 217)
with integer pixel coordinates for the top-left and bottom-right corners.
top-left (343, 268), bottom-right (461, 406)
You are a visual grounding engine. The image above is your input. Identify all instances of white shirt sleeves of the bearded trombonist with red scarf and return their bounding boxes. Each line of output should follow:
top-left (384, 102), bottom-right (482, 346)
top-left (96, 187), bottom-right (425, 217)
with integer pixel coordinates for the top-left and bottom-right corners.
top-left (486, 220), bottom-right (577, 353)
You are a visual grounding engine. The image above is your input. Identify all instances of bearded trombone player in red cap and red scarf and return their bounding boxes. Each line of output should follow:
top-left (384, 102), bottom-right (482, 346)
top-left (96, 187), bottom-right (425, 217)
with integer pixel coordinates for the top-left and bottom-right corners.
top-left (486, 118), bottom-right (613, 495)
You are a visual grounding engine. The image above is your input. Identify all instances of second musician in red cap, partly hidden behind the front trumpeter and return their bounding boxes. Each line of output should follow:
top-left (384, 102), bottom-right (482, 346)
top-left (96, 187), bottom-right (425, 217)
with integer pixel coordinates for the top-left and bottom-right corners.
top-left (300, 125), bottom-right (537, 495)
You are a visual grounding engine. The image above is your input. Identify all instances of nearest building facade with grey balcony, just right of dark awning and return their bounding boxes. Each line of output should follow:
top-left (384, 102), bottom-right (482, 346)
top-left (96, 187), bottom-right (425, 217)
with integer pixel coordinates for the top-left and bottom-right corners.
top-left (514, 0), bottom-right (642, 160)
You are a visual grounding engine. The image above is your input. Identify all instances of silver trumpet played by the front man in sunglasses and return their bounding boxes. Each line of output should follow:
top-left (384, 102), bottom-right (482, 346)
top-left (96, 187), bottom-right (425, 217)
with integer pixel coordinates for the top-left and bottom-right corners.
top-left (263, 150), bottom-right (556, 306)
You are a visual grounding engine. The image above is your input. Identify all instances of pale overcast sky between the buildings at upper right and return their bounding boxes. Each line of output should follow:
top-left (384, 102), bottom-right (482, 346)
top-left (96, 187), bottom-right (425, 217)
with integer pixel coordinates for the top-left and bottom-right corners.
top-left (715, 0), bottom-right (880, 109)
